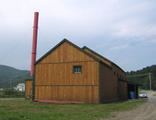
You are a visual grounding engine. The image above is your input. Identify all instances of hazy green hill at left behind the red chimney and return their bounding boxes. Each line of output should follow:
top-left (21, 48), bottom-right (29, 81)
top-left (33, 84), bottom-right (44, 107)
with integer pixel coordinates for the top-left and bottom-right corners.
top-left (0, 65), bottom-right (30, 88)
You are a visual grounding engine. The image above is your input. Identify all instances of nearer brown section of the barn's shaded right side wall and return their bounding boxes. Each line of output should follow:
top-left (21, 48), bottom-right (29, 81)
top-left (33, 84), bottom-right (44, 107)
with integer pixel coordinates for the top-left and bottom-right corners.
top-left (99, 64), bottom-right (118, 102)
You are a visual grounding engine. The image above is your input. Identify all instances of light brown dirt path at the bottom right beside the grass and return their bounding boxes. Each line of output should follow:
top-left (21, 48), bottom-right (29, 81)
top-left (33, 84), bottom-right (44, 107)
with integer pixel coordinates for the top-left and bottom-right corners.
top-left (108, 95), bottom-right (156, 120)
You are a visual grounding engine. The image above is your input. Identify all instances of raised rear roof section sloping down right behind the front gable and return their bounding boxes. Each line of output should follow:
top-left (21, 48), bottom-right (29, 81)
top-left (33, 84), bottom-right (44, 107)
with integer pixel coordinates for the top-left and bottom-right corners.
top-left (82, 46), bottom-right (125, 73)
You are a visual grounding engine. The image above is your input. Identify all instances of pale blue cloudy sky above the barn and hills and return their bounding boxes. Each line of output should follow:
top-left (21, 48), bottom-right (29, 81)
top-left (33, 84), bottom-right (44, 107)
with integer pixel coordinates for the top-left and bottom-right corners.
top-left (0, 0), bottom-right (156, 71)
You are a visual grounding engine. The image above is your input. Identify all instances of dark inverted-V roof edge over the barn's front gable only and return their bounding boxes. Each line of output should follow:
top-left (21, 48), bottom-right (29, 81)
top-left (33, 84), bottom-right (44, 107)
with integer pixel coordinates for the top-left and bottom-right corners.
top-left (35, 39), bottom-right (100, 64)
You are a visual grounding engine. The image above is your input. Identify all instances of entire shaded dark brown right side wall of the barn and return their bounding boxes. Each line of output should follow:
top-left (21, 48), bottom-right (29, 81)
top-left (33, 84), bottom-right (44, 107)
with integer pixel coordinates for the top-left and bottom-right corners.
top-left (99, 64), bottom-right (127, 102)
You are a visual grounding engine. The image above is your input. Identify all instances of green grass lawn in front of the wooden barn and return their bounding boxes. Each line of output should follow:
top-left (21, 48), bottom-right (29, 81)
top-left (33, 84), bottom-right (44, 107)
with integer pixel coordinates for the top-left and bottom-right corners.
top-left (0, 99), bottom-right (144, 120)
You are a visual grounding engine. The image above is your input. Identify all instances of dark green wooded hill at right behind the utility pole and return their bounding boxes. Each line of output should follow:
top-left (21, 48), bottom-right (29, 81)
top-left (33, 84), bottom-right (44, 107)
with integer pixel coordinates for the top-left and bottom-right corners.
top-left (127, 65), bottom-right (156, 90)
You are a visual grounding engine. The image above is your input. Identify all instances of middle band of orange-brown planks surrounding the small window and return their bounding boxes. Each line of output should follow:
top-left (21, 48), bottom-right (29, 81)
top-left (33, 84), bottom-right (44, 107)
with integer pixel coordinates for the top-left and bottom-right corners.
top-left (35, 62), bottom-right (98, 85)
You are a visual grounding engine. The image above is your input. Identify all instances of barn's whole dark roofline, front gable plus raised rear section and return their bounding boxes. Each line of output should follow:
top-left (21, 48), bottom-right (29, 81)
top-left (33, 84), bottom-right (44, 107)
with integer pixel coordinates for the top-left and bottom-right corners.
top-left (36, 39), bottom-right (124, 72)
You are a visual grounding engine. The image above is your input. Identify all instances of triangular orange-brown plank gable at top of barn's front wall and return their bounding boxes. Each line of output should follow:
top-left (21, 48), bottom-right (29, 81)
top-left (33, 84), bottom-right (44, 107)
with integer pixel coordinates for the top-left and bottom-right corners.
top-left (40, 42), bottom-right (94, 64)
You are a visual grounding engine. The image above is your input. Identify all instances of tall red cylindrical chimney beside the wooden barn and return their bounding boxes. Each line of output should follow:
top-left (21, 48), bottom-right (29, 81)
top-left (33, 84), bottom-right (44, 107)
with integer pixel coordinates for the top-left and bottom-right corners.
top-left (30, 12), bottom-right (39, 77)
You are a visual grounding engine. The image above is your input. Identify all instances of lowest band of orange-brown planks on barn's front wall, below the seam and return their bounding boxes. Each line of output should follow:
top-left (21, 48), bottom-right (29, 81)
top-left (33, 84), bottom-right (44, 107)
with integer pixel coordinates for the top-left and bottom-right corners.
top-left (36, 86), bottom-right (99, 103)
